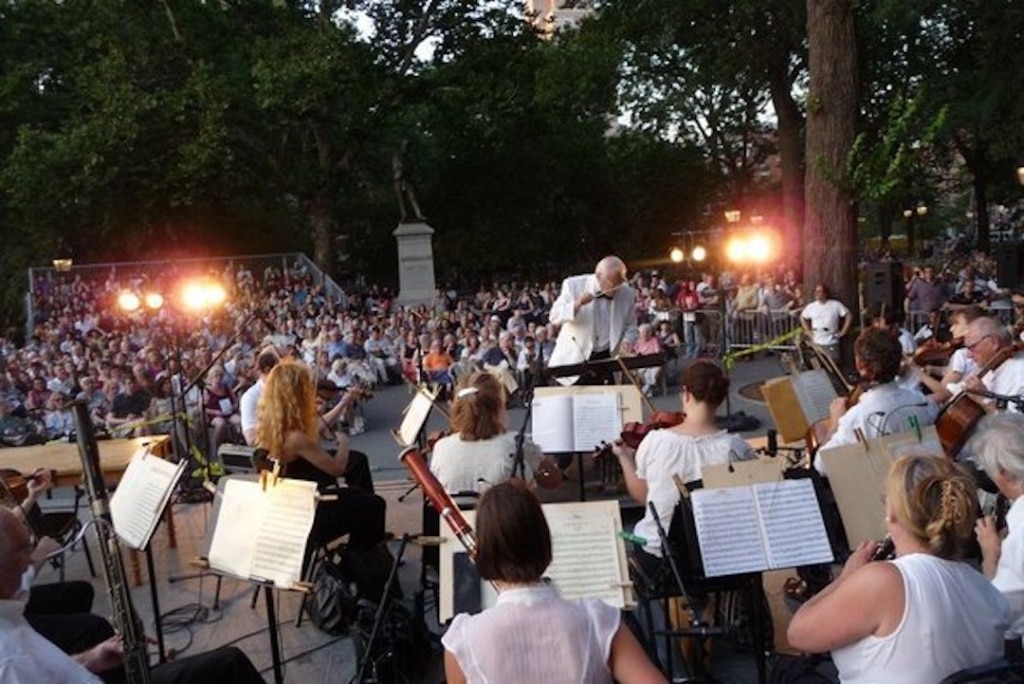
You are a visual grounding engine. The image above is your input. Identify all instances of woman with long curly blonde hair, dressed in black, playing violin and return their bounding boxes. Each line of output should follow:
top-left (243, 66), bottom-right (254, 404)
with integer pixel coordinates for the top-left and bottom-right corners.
top-left (256, 360), bottom-right (385, 551)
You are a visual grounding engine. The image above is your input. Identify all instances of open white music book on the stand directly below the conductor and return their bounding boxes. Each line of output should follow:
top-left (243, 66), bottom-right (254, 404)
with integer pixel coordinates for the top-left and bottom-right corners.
top-left (531, 390), bottom-right (623, 454)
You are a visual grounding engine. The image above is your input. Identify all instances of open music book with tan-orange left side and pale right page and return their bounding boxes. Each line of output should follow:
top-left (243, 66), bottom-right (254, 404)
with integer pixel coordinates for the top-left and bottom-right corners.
top-left (761, 370), bottom-right (838, 442)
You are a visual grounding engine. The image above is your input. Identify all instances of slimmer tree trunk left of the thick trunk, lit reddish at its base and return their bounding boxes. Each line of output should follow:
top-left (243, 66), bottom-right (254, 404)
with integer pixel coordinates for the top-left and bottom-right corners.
top-left (770, 63), bottom-right (804, 266)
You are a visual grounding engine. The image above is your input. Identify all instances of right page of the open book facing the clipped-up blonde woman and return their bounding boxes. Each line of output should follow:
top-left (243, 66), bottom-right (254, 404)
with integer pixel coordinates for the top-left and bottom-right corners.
top-left (753, 478), bottom-right (834, 569)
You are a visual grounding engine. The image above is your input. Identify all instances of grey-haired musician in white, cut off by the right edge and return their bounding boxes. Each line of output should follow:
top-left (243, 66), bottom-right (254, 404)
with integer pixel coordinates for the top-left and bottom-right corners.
top-left (969, 413), bottom-right (1024, 632)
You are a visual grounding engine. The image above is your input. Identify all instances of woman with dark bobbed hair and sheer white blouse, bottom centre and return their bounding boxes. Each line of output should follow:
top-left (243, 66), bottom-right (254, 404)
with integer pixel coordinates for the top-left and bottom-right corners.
top-left (441, 480), bottom-right (665, 684)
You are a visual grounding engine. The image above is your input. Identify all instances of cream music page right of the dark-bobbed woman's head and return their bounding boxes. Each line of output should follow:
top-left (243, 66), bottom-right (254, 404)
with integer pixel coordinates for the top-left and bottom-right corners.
top-left (544, 501), bottom-right (632, 608)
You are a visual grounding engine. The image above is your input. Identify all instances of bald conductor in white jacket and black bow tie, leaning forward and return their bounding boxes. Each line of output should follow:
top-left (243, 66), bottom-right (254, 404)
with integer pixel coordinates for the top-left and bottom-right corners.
top-left (548, 256), bottom-right (637, 385)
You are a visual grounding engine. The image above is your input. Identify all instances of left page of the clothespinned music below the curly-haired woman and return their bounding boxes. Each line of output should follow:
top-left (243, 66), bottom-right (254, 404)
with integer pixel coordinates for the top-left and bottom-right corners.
top-left (207, 478), bottom-right (264, 580)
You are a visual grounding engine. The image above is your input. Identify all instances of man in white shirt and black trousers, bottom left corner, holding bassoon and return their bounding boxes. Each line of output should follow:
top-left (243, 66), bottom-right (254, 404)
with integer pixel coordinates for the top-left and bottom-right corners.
top-left (0, 507), bottom-right (263, 684)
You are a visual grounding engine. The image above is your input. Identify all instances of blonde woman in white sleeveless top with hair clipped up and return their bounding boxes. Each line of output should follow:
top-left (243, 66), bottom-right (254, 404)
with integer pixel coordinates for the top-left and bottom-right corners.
top-left (783, 456), bottom-right (1009, 684)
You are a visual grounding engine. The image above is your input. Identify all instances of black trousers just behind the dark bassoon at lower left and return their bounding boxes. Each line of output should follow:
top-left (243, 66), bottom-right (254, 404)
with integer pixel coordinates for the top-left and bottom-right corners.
top-left (25, 582), bottom-right (114, 655)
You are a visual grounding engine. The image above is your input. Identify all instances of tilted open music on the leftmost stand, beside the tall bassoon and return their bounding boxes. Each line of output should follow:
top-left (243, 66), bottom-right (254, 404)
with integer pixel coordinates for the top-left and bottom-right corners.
top-left (111, 448), bottom-right (187, 550)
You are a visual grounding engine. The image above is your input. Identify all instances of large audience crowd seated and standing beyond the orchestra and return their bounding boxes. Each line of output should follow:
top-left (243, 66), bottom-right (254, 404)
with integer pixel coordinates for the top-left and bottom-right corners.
top-left (0, 248), bottom-right (1012, 447)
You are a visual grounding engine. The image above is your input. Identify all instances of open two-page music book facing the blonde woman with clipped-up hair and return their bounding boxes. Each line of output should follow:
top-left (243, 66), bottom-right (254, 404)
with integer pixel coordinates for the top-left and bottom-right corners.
top-left (691, 479), bottom-right (834, 578)
